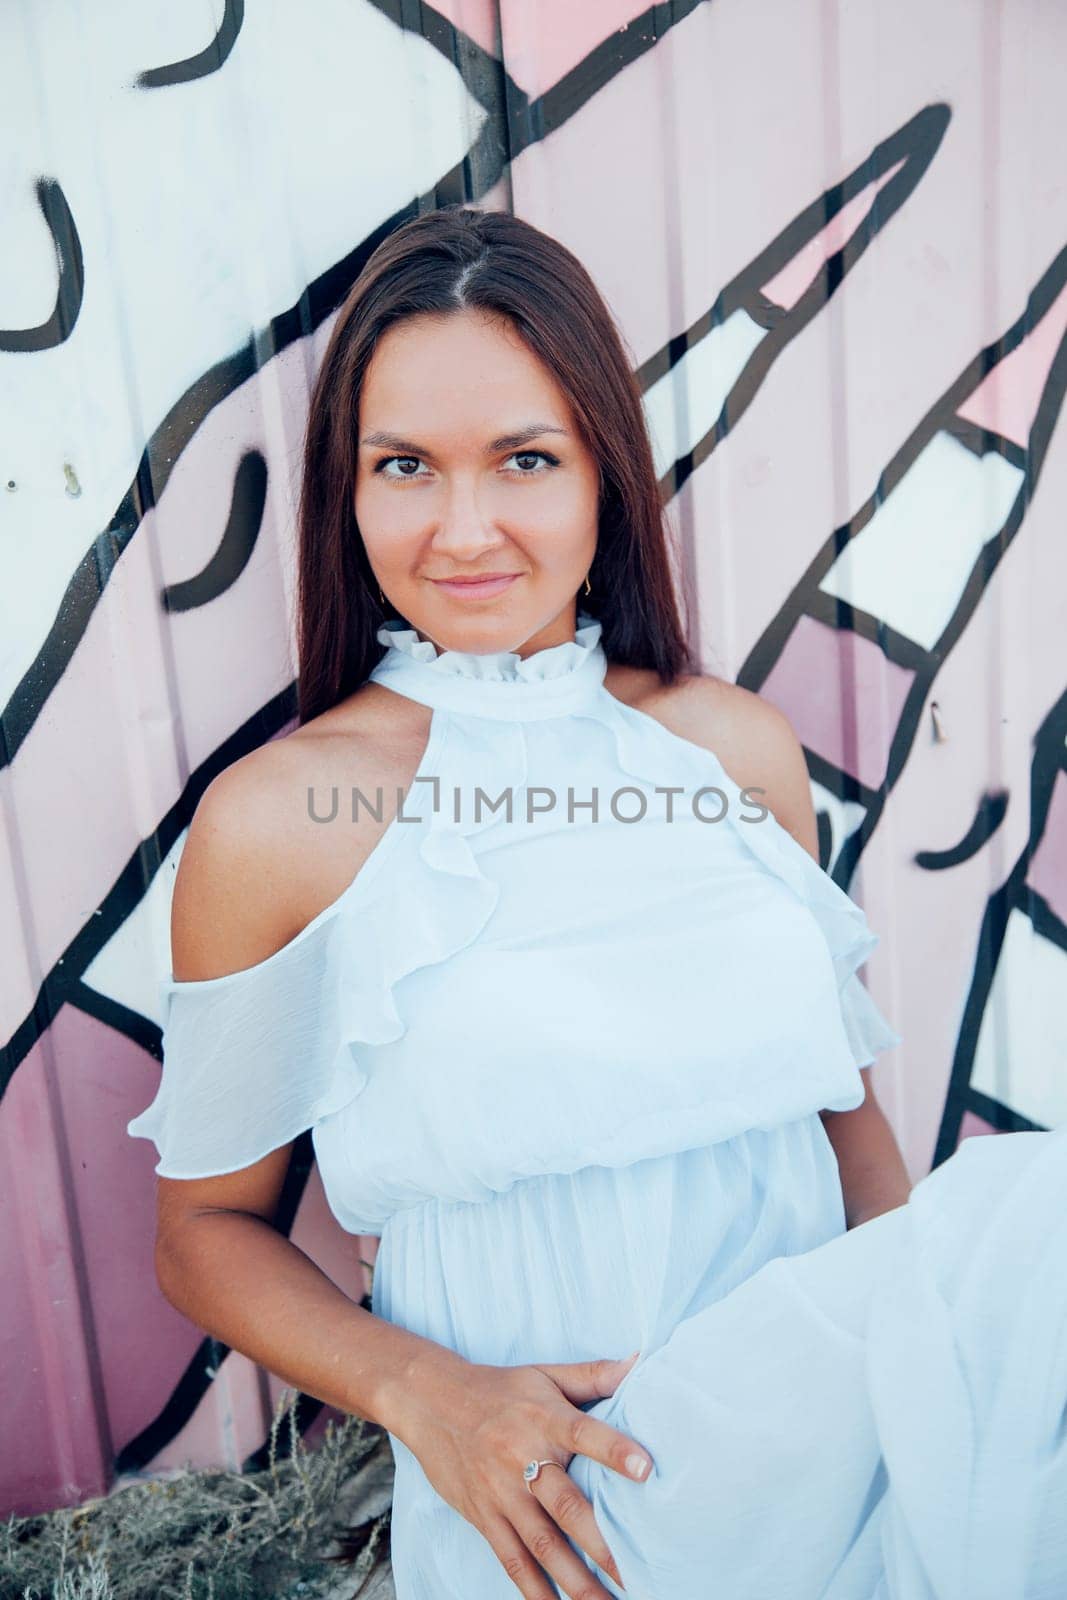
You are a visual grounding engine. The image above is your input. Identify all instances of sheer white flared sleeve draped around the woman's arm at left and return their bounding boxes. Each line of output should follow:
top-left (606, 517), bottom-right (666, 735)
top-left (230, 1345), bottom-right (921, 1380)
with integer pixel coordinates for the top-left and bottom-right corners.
top-left (126, 909), bottom-right (366, 1178)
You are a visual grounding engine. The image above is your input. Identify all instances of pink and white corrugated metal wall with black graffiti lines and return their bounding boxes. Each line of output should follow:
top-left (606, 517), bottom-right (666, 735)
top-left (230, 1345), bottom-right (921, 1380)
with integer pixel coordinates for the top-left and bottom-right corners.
top-left (0, 0), bottom-right (1067, 1512)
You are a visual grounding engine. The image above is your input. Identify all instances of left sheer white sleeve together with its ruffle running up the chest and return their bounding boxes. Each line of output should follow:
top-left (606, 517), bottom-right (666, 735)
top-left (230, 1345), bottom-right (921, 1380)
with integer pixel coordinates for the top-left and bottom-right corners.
top-left (126, 720), bottom-right (502, 1181)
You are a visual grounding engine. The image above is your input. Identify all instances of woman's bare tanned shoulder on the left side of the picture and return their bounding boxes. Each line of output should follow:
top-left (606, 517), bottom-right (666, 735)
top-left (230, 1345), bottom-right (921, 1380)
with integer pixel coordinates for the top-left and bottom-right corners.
top-left (171, 685), bottom-right (427, 981)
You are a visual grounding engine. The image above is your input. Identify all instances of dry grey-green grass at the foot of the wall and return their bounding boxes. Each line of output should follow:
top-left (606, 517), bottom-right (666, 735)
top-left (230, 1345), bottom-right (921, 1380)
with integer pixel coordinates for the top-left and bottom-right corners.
top-left (0, 1390), bottom-right (392, 1600)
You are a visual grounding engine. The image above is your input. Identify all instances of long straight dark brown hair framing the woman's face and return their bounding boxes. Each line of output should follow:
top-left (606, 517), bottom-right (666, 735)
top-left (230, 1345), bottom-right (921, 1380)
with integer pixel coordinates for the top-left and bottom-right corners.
top-left (298, 206), bottom-right (693, 723)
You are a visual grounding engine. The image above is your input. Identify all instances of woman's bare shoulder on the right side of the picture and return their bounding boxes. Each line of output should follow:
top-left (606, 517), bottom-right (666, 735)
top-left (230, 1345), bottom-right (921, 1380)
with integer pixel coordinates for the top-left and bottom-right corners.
top-left (607, 672), bottom-right (819, 861)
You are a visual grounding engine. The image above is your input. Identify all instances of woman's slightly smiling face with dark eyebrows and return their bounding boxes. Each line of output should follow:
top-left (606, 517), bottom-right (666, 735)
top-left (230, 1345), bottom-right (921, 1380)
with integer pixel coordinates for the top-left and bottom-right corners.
top-left (355, 310), bottom-right (600, 656)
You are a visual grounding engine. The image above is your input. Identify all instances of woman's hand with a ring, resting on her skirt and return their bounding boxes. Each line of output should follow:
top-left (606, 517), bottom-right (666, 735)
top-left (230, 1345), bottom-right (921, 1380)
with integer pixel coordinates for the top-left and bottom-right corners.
top-left (389, 1352), bottom-right (651, 1600)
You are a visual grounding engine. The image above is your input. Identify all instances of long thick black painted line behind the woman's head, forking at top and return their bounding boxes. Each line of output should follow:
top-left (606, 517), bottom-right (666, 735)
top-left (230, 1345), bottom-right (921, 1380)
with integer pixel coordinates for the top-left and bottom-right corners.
top-left (0, 0), bottom-right (710, 770)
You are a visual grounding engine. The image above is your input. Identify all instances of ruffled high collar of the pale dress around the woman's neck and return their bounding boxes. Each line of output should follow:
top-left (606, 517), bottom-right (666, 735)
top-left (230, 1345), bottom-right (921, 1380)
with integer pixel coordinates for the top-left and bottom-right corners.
top-left (370, 611), bottom-right (608, 722)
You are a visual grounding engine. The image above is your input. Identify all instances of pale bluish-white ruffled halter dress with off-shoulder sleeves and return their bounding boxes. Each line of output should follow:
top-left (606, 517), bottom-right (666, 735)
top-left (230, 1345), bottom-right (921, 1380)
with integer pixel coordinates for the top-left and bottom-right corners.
top-left (128, 614), bottom-right (1067, 1600)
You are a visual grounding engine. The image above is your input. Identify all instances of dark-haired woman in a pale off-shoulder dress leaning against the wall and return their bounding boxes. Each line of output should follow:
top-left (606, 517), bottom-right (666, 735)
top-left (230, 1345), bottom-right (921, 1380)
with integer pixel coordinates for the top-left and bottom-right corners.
top-left (130, 210), bottom-right (1062, 1600)
